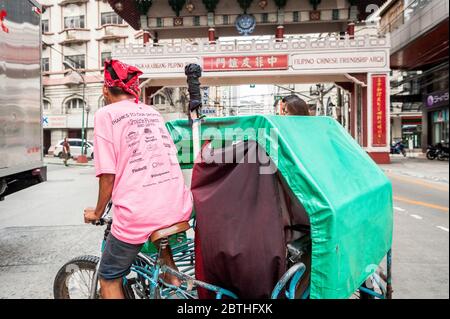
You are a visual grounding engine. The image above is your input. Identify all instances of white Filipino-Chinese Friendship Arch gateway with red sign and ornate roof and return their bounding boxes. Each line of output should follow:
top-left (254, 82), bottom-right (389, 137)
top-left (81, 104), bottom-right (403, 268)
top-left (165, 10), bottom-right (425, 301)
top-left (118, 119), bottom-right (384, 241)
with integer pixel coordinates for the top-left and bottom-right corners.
top-left (108, 0), bottom-right (390, 163)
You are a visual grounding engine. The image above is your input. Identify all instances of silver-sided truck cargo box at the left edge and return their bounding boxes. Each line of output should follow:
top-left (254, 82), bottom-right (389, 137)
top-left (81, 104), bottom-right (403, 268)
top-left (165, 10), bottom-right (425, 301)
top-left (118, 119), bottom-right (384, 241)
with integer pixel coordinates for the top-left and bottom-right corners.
top-left (0, 0), bottom-right (47, 200)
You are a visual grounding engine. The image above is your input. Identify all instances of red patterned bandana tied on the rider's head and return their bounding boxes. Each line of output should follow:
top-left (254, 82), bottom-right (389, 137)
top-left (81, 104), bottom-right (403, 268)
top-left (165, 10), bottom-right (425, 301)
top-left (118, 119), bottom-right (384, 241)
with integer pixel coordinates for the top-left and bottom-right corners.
top-left (105, 60), bottom-right (143, 103)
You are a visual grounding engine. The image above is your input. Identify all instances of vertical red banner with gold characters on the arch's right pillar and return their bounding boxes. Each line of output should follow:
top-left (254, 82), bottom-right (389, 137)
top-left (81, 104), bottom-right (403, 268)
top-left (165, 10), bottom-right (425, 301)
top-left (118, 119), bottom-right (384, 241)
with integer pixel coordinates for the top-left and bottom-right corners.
top-left (372, 75), bottom-right (387, 147)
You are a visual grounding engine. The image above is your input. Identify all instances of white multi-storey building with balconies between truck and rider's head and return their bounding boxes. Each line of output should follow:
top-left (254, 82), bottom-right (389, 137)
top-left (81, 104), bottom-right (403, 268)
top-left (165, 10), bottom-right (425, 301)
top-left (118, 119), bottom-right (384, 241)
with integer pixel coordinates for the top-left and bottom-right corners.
top-left (40, 0), bottom-right (142, 151)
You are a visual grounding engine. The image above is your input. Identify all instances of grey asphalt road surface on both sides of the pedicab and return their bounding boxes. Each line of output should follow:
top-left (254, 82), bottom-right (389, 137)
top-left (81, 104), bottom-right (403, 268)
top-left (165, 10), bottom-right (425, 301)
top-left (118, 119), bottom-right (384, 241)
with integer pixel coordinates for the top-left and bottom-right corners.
top-left (0, 162), bottom-right (449, 298)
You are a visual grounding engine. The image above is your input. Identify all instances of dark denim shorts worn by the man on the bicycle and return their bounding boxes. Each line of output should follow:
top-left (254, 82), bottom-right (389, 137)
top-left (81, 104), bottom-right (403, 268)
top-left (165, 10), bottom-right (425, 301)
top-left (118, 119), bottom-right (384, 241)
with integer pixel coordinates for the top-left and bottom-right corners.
top-left (98, 234), bottom-right (144, 280)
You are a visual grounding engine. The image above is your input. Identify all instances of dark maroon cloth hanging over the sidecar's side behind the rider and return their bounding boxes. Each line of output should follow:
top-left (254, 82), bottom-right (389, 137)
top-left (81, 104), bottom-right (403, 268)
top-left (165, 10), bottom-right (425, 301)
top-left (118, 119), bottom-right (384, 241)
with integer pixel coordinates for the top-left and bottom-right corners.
top-left (192, 141), bottom-right (304, 299)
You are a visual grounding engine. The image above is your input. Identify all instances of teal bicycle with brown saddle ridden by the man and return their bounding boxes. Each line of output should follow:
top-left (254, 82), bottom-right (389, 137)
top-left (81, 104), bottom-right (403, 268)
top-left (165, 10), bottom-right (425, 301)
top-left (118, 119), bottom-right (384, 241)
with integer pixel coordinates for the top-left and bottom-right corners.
top-left (53, 202), bottom-right (237, 299)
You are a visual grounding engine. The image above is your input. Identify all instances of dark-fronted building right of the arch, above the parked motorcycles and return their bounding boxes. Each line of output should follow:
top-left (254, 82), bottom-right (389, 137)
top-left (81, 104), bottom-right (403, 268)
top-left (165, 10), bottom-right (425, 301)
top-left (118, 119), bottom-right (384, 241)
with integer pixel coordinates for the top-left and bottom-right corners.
top-left (379, 0), bottom-right (449, 152)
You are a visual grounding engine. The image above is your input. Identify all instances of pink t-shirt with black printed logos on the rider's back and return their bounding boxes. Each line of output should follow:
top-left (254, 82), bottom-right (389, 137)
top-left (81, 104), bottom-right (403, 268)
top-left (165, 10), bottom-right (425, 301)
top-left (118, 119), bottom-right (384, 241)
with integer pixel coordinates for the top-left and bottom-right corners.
top-left (94, 100), bottom-right (192, 244)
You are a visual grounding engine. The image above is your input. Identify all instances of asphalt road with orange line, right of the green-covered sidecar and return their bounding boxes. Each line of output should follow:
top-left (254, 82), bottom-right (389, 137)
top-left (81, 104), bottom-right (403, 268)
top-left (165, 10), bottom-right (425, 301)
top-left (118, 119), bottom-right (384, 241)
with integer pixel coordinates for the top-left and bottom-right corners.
top-left (388, 173), bottom-right (449, 299)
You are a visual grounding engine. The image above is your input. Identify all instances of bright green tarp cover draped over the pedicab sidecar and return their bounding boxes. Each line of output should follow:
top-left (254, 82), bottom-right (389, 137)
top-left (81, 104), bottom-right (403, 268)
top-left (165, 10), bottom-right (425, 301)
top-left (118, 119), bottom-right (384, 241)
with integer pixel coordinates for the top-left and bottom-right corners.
top-left (167, 115), bottom-right (393, 298)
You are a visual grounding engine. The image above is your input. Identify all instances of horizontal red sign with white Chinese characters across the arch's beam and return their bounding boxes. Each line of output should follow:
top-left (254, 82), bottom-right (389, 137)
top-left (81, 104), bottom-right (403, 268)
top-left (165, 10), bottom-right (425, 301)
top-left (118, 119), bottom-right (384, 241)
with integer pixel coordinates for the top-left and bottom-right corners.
top-left (203, 54), bottom-right (289, 72)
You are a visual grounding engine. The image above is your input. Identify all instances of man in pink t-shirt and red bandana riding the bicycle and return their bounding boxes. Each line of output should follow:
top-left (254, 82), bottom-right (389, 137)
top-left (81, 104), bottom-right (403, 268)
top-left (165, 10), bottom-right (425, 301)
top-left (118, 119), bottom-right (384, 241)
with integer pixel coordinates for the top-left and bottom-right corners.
top-left (84, 60), bottom-right (192, 298)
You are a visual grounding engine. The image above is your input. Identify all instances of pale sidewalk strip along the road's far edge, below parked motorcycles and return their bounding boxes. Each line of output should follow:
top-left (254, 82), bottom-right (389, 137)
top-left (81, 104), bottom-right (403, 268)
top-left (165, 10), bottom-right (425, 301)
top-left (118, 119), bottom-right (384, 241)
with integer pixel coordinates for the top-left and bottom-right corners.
top-left (379, 154), bottom-right (449, 184)
